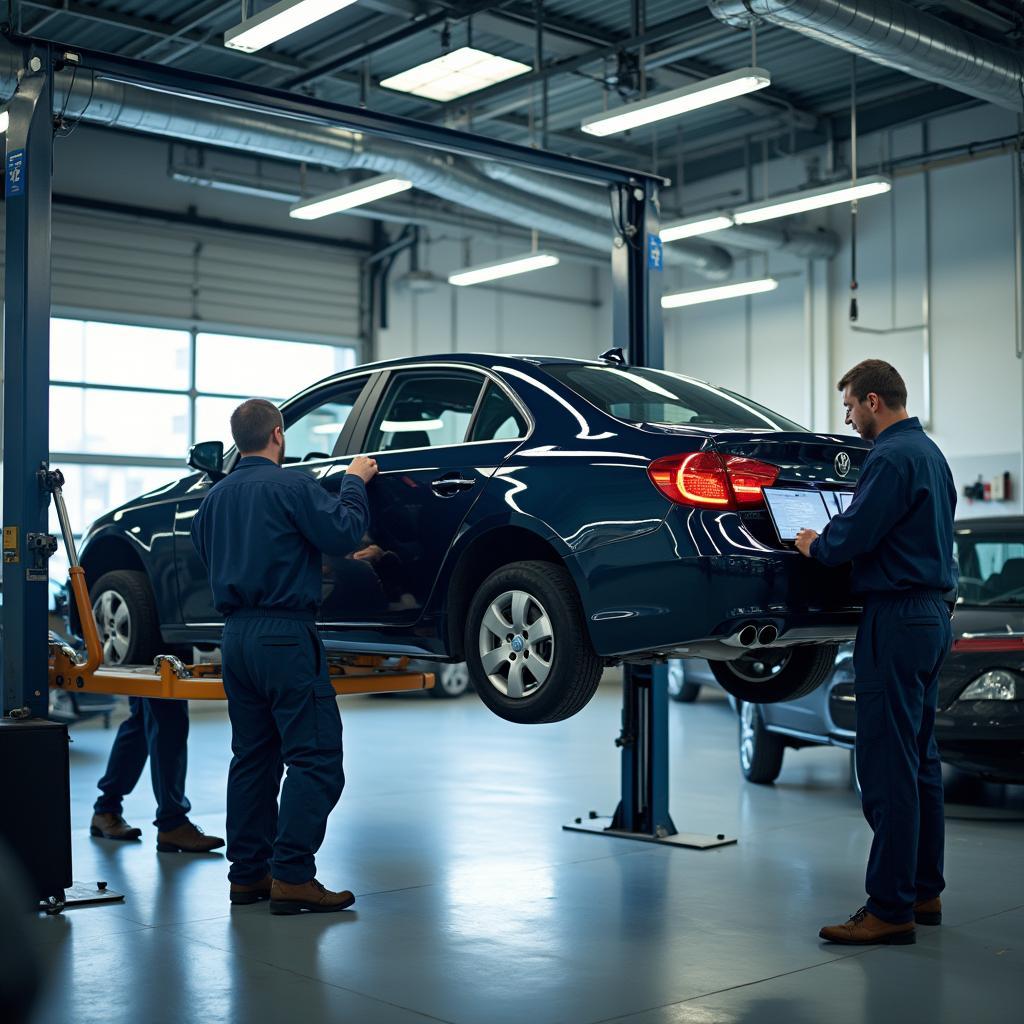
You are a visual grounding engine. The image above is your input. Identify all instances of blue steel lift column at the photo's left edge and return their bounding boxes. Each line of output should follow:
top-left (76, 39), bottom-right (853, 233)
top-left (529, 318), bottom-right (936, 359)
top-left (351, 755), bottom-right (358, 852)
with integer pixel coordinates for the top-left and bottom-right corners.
top-left (0, 47), bottom-right (55, 718)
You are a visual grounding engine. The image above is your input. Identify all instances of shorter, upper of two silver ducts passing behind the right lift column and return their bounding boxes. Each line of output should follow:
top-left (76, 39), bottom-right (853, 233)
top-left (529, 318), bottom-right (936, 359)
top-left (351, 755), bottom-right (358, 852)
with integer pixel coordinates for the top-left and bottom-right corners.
top-left (477, 161), bottom-right (839, 262)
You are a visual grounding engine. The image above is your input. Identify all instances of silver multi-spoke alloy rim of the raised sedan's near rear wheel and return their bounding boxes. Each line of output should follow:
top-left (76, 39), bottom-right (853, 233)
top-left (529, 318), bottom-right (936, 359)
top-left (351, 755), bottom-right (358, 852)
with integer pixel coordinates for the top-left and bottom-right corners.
top-left (479, 590), bottom-right (555, 699)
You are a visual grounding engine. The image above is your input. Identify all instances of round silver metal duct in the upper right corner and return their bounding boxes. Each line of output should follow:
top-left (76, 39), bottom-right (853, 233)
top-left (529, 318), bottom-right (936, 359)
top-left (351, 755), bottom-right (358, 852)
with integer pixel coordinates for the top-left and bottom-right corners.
top-left (708, 0), bottom-right (1024, 113)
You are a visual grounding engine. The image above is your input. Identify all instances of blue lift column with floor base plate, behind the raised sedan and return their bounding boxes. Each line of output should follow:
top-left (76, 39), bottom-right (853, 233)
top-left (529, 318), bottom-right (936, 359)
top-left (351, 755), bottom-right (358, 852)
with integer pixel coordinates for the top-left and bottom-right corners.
top-left (564, 179), bottom-right (736, 850)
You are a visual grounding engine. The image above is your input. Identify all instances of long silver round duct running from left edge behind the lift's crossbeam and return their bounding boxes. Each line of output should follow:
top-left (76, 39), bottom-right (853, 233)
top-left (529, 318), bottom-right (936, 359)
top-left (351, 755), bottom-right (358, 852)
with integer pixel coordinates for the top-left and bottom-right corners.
top-left (0, 43), bottom-right (732, 279)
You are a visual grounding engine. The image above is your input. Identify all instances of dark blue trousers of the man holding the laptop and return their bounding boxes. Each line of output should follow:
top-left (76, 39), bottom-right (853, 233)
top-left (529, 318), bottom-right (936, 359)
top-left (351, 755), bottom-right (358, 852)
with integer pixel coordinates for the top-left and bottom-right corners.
top-left (853, 594), bottom-right (952, 924)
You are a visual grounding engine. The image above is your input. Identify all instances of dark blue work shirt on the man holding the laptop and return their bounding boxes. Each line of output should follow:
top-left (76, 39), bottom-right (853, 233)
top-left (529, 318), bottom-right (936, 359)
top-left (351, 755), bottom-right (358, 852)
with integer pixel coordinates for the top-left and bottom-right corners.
top-left (811, 417), bottom-right (957, 594)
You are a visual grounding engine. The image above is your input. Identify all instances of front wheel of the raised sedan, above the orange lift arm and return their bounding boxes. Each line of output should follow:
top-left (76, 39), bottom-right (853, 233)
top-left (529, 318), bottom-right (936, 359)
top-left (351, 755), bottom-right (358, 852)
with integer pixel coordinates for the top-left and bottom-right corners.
top-left (89, 569), bottom-right (160, 665)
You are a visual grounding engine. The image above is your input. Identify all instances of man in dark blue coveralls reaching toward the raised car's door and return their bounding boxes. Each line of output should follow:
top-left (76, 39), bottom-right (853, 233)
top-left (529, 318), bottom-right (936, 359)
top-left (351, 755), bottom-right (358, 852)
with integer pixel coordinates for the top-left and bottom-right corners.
top-left (191, 398), bottom-right (377, 914)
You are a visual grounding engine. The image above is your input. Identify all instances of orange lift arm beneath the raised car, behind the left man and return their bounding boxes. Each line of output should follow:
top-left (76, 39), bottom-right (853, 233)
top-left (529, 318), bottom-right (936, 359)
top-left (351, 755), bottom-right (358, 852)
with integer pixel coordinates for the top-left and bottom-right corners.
top-left (46, 469), bottom-right (434, 700)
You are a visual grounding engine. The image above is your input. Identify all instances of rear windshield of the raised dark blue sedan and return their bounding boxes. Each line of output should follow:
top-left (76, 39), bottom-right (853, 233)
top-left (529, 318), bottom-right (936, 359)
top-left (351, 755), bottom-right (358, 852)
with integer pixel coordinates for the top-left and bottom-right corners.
top-left (544, 362), bottom-right (805, 431)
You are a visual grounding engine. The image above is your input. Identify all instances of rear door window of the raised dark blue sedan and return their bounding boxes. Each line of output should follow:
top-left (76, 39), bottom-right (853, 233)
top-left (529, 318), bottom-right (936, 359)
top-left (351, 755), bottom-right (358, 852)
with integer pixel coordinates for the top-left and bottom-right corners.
top-left (364, 370), bottom-right (483, 452)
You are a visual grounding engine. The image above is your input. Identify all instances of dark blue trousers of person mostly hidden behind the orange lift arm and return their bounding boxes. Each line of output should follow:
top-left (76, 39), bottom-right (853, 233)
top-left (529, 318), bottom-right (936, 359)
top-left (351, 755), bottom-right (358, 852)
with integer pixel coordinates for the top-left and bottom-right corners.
top-left (93, 697), bottom-right (191, 831)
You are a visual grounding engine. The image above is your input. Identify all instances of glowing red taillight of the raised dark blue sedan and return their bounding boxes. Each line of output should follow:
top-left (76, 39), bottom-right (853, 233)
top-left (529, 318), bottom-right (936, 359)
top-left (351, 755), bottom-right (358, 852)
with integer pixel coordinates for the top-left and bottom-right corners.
top-left (647, 452), bottom-right (778, 509)
